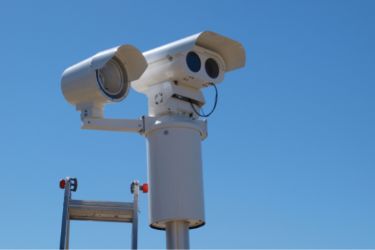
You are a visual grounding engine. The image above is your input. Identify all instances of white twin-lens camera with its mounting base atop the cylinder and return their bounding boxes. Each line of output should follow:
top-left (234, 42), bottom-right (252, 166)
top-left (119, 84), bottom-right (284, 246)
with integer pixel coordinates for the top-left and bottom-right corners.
top-left (131, 31), bottom-right (246, 116)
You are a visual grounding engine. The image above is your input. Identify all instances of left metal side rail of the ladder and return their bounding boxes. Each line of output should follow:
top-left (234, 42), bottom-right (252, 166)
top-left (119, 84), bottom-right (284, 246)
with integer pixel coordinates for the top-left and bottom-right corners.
top-left (60, 178), bottom-right (71, 250)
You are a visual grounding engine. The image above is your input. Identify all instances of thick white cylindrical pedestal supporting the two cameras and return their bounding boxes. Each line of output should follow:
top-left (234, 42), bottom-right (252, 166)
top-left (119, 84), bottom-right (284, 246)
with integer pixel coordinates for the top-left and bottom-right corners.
top-left (146, 122), bottom-right (204, 229)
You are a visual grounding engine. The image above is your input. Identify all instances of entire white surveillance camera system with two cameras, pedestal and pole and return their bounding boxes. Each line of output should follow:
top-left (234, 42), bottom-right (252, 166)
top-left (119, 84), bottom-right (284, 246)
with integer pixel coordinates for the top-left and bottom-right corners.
top-left (62, 31), bottom-right (246, 249)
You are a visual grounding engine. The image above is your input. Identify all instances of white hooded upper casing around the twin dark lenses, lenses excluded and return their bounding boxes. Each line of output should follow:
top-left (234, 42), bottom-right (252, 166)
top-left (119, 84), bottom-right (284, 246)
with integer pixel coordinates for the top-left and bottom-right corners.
top-left (131, 31), bottom-right (246, 93)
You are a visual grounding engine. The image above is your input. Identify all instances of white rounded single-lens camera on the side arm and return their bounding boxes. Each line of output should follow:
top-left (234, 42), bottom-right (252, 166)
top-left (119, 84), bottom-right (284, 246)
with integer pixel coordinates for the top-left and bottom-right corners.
top-left (61, 45), bottom-right (147, 118)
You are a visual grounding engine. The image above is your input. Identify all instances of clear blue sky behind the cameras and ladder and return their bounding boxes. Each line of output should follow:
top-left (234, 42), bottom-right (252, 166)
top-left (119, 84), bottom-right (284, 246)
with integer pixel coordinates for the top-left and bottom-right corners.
top-left (0, 0), bottom-right (375, 248)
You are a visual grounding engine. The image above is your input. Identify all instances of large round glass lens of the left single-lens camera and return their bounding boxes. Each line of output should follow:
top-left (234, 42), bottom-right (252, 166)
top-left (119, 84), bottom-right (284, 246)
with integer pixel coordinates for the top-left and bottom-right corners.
top-left (97, 58), bottom-right (128, 99)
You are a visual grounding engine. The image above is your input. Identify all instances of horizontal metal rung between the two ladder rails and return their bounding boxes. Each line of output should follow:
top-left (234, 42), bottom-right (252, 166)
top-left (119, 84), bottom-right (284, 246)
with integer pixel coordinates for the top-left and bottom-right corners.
top-left (69, 200), bottom-right (133, 222)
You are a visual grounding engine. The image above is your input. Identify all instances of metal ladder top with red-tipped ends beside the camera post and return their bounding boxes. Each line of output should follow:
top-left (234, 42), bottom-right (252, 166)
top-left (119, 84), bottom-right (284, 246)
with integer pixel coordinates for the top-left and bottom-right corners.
top-left (59, 177), bottom-right (148, 250)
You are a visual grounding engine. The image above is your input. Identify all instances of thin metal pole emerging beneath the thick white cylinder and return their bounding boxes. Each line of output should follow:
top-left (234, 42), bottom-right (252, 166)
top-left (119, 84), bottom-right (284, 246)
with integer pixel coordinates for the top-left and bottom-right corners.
top-left (166, 221), bottom-right (189, 249)
